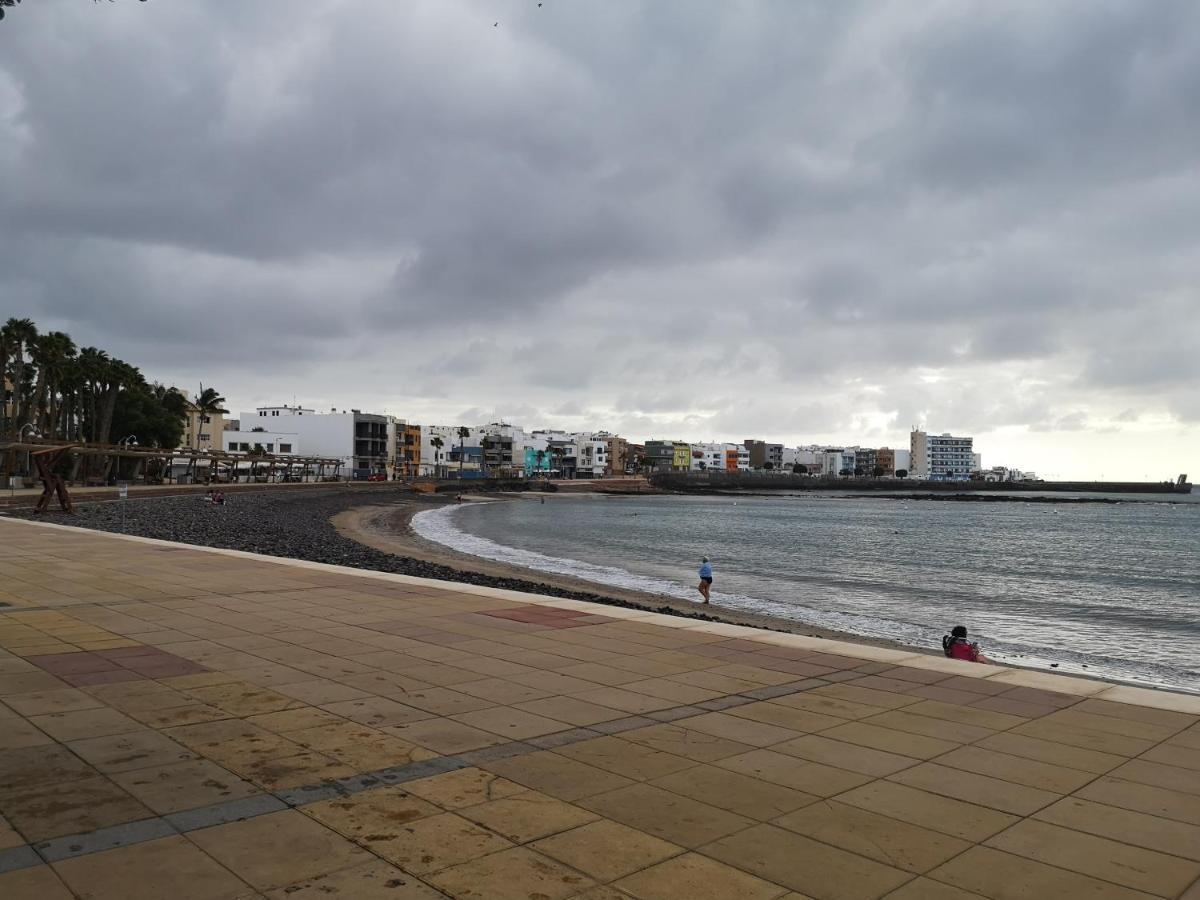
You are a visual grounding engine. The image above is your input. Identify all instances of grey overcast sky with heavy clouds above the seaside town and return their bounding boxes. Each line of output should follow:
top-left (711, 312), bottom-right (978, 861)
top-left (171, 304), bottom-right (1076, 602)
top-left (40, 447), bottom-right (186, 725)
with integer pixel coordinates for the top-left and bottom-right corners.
top-left (0, 0), bottom-right (1200, 479)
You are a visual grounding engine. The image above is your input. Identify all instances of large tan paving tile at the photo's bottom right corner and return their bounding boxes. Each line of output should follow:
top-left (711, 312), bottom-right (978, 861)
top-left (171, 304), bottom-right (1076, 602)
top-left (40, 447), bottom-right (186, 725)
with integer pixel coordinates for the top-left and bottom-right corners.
top-left (988, 820), bottom-right (1200, 898)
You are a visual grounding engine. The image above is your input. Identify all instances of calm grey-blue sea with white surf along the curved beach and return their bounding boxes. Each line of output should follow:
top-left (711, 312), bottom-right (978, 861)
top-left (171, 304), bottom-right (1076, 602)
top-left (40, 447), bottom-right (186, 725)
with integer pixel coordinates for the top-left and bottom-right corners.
top-left (413, 494), bottom-right (1200, 692)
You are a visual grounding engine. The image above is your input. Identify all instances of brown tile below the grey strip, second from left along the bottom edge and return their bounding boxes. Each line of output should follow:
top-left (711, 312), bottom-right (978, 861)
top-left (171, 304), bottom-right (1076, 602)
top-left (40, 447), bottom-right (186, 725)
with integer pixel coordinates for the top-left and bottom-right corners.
top-left (54, 838), bottom-right (250, 900)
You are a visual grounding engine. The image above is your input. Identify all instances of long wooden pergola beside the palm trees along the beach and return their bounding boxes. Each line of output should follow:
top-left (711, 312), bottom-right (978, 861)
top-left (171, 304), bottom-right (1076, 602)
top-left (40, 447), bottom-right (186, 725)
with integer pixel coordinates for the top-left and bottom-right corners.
top-left (0, 438), bottom-right (342, 512)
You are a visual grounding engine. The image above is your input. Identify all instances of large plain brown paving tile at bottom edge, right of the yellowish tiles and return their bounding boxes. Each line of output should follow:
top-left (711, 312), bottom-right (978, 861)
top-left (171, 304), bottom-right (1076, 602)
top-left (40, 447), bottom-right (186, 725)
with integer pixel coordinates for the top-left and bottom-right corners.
top-left (702, 824), bottom-right (912, 900)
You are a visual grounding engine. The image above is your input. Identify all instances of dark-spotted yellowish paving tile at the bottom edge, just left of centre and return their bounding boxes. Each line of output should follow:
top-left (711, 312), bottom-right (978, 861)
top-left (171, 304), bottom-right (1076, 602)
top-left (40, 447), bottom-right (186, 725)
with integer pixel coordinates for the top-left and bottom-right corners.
top-left (430, 847), bottom-right (594, 900)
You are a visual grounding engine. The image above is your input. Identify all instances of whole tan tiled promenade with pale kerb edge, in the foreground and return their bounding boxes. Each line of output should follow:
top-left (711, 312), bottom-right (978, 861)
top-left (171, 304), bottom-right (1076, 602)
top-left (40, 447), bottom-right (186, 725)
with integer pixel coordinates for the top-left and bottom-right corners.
top-left (7, 520), bottom-right (1200, 900)
